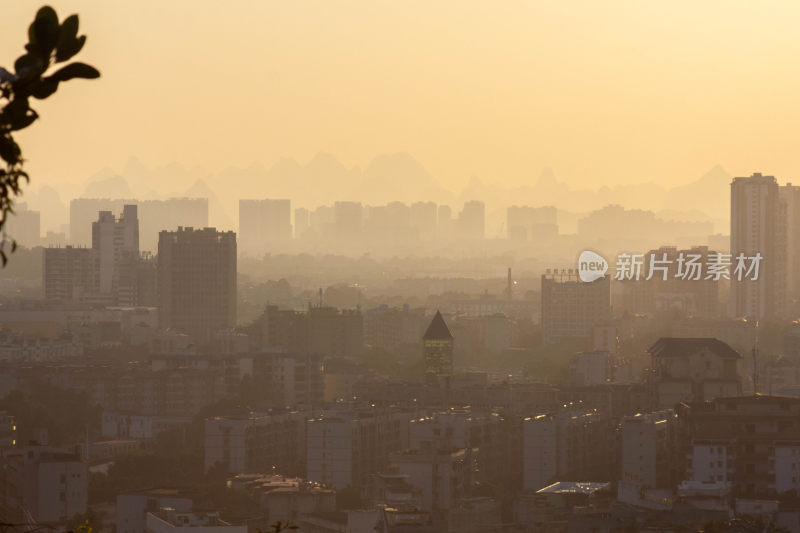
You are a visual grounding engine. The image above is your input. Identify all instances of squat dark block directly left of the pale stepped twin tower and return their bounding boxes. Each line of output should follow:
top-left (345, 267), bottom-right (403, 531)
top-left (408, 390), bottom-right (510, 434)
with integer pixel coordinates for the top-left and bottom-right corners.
top-left (42, 246), bottom-right (100, 302)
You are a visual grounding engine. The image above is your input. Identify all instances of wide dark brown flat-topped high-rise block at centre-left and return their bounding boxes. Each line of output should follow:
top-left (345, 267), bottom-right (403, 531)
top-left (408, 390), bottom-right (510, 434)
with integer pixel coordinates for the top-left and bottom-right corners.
top-left (158, 228), bottom-right (236, 342)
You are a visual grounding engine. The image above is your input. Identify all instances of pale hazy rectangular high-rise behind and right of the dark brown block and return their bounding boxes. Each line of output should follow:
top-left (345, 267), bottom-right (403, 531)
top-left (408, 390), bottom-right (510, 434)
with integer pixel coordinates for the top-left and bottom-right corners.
top-left (239, 200), bottom-right (292, 257)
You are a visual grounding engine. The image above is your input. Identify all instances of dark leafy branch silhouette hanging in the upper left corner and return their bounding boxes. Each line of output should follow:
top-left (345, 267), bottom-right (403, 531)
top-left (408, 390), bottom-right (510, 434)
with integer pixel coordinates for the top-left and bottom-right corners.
top-left (0, 6), bottom-right (100, 266)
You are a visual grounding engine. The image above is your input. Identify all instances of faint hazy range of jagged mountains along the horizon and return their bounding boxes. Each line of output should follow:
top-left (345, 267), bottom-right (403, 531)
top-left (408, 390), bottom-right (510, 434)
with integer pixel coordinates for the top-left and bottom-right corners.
top-left (72, 156), bottom-right (732, 235)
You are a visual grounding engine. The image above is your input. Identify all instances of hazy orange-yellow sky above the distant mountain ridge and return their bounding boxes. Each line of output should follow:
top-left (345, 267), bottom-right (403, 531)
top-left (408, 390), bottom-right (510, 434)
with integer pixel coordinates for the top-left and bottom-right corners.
top-left (0, 0), bottom-right (800, 190)
